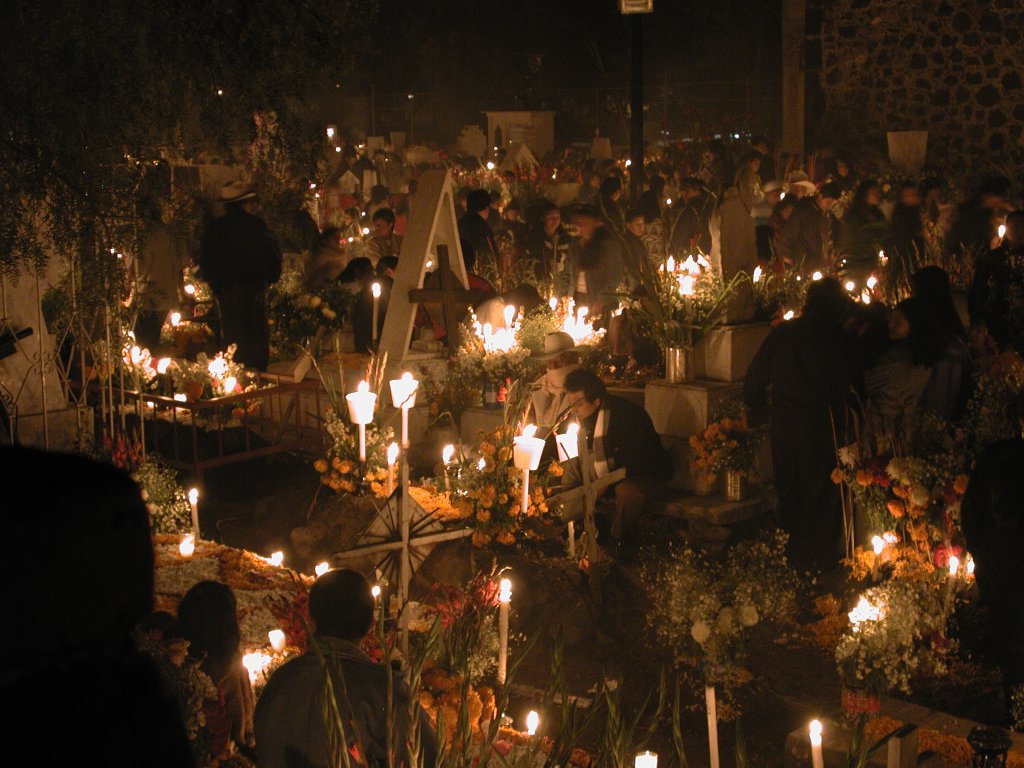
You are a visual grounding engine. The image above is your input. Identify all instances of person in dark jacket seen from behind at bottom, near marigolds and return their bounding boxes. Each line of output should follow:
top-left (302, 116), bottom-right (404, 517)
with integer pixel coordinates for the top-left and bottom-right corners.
top-left (256, 570), bottom-right (437, 768)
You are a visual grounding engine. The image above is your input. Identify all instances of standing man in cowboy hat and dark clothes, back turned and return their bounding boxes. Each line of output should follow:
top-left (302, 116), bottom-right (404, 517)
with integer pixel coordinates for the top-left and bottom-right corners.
top-left (199, 181), bottom-right (282, 371)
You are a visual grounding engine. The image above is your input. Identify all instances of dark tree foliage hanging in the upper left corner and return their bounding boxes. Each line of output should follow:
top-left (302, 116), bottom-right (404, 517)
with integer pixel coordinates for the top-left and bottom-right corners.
top-left (0, 0), bottom-right (375, 269)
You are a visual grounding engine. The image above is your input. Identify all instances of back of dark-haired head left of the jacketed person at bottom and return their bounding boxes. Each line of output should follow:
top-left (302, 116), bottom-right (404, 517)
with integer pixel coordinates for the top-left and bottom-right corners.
top-left (177, 581), bottom-right (242, 662)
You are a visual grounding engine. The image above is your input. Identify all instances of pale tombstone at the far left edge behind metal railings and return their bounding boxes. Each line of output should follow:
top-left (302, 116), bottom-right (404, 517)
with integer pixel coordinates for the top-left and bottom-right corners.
top-left (0, 270), bottom-right (81, 450)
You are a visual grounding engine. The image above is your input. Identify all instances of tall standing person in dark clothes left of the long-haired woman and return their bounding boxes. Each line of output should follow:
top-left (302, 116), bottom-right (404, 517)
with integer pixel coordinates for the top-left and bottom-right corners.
top-left (743, 278), bottom-right (853, 567)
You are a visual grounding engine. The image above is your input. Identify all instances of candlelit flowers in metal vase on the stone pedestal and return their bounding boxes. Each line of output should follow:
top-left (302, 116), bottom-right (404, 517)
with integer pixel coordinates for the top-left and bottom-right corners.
top-left (623, 253), bottom-right (743, 348)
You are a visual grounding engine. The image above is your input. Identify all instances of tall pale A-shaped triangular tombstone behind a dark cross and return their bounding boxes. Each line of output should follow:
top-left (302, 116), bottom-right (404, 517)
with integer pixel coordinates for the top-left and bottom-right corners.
top-left (379, 170), bottom-right (489, 378)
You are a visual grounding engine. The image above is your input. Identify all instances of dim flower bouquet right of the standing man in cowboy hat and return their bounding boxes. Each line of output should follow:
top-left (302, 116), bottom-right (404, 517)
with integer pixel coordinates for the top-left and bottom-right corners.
top-left (267, 270), bottom-right (356, 353)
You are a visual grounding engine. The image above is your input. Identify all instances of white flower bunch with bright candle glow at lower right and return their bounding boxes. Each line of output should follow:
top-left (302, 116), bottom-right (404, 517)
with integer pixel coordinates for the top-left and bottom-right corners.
top-left (836, 571), bottom-right (949, 696)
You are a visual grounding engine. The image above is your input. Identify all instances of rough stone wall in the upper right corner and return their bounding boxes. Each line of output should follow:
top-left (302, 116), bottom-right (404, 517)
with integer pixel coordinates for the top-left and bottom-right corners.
top-left (809, 0), bottom-right (1024, 176)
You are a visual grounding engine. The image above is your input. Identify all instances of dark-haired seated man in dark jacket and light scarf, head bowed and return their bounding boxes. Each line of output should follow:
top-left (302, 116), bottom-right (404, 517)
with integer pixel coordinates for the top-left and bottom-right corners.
top-left (562, 368), bottom-right (672, 551)
